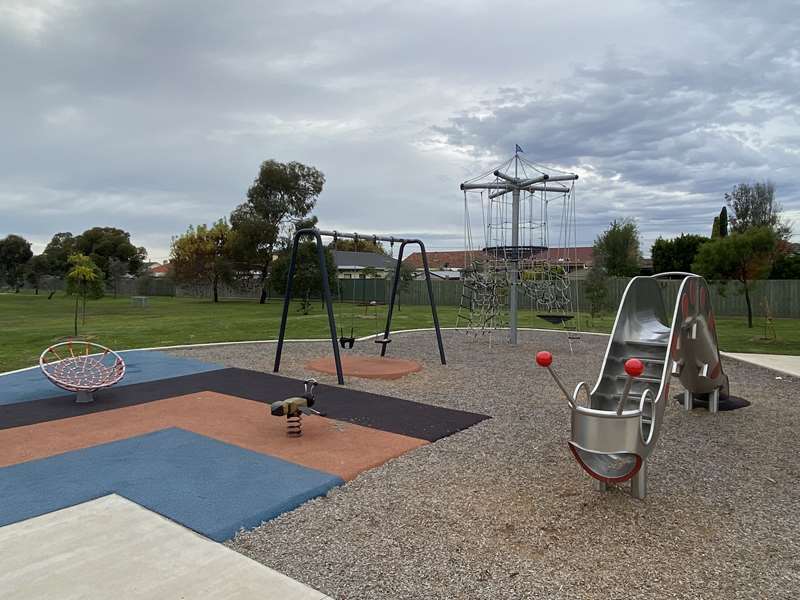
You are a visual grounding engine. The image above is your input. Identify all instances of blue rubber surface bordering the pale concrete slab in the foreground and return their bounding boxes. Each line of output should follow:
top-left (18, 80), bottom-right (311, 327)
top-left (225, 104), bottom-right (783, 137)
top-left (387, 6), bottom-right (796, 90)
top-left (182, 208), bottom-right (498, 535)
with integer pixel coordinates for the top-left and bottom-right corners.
top-left (0, 428), bottom-right (344, 541)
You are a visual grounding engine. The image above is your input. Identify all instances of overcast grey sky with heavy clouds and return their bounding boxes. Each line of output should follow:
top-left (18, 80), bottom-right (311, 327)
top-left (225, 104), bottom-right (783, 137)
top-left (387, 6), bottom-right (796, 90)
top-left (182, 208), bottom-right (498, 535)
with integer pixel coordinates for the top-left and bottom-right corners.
top-left (0, 0), bottom-right (800, 260)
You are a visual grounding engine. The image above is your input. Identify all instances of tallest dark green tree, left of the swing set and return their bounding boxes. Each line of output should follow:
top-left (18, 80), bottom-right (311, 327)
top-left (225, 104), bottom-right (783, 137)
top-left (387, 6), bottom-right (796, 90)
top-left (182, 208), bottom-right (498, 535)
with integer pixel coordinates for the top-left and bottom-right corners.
top-left (231, 160), bottom-right (325, 304)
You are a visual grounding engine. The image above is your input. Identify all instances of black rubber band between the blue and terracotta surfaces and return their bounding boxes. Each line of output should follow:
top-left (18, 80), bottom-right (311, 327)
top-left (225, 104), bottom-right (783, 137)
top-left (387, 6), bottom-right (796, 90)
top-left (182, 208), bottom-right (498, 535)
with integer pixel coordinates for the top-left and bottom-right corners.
top-left (0, 369), bottom-right (489, 442)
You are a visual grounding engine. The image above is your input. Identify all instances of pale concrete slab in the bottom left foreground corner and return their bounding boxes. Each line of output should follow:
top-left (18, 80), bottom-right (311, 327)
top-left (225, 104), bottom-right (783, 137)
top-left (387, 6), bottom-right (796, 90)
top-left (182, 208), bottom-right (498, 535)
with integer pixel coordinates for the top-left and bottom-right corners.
top-left (0, 494), bottom-right (330, 600)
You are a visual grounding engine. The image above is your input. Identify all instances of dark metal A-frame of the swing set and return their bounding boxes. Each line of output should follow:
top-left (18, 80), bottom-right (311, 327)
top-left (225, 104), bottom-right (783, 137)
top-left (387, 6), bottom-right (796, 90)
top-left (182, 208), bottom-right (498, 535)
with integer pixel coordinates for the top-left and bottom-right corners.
top-left (273, 228), bottom-right (447, 385)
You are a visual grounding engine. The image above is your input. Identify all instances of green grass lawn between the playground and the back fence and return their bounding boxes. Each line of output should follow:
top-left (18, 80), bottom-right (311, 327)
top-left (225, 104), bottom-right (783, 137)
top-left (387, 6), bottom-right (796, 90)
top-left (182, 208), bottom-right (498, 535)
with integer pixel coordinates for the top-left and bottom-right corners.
top-left (0, 294), bottom-right (800, 372)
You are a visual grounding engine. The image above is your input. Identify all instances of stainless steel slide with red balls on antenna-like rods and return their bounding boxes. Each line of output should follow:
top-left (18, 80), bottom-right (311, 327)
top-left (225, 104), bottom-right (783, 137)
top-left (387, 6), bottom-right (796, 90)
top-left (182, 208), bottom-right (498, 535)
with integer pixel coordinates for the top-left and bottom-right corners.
top-left (536, 273), bottom-right (729, 498)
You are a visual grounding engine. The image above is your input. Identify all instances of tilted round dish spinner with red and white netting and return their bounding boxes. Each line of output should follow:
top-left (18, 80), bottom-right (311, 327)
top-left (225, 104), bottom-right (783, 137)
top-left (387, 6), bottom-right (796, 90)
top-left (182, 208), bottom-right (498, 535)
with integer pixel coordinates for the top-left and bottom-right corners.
top-left (39, 340), bottom-right (125, 403)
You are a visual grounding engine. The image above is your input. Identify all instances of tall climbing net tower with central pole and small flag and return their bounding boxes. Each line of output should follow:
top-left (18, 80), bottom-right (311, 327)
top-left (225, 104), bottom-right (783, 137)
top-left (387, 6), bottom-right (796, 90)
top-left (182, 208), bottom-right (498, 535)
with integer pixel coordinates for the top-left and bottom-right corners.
top-left (456, 146), bottom-right (578, 344)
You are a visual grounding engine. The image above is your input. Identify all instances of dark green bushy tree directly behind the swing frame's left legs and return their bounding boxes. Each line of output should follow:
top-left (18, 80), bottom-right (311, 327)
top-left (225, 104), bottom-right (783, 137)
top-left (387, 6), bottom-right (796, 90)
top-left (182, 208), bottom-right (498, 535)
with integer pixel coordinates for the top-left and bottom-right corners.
top-left (272, 229), bottom-right (337, 315)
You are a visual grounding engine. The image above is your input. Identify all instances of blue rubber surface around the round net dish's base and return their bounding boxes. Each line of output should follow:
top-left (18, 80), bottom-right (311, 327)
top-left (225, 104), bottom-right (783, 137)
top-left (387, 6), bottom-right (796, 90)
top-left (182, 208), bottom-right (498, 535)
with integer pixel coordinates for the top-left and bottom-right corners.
top-left (0, 350), bottom-right (224, 405)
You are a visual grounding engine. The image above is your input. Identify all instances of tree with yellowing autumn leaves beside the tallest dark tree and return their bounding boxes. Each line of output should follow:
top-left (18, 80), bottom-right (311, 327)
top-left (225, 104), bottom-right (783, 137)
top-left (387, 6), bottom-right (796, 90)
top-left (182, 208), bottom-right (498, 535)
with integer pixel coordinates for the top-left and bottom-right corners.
top-left (170, 219), bottom-right (234, 302)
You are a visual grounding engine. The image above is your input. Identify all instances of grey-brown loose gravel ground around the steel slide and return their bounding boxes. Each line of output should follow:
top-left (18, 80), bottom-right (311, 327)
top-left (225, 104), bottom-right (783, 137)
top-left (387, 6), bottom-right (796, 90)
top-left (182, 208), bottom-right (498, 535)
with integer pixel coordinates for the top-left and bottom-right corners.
top-left (169, 332), bottom-right (800, 600)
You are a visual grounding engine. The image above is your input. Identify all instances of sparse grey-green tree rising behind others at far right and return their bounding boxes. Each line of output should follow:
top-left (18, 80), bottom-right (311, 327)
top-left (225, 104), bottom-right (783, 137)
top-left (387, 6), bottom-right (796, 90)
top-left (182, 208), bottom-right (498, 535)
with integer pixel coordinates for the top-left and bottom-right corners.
top-left (720, 181), bottom-right (792, 240)
